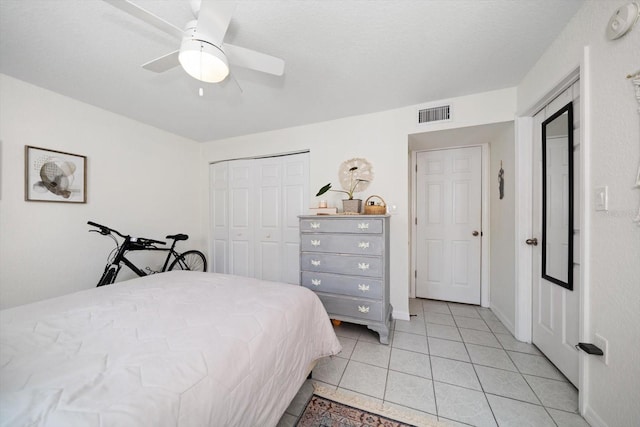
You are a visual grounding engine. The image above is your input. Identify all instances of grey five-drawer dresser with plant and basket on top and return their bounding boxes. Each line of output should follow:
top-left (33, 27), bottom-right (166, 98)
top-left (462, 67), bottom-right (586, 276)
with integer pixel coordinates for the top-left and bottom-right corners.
top-left (299, 215), bottom-right (392, 344)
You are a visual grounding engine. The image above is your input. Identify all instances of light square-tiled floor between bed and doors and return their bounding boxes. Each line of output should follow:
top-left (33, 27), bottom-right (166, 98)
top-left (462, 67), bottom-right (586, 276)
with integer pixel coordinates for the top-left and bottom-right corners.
top-left (279, 299), bottom-right (588, 427)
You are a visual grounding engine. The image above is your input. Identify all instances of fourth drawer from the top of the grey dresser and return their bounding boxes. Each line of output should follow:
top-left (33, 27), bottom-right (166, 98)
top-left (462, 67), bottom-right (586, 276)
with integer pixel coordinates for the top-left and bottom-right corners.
top-left (302, 271), bottom-right (383, 299)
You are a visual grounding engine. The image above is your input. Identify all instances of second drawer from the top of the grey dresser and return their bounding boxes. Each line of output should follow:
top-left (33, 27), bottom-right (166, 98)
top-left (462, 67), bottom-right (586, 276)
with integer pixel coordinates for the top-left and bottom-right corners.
top-left (300, 233), bottom-right (384, 255)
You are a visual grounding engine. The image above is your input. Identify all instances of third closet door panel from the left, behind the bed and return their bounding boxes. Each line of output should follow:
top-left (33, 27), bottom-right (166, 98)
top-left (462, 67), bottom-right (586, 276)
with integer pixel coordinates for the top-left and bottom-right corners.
top-left (254, 157), bottom-right (283, 281)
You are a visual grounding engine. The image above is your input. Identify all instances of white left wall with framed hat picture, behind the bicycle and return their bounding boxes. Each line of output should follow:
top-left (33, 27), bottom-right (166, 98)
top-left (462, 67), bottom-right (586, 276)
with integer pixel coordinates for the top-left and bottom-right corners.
top-left (0, 75), bottom-right (206, 308)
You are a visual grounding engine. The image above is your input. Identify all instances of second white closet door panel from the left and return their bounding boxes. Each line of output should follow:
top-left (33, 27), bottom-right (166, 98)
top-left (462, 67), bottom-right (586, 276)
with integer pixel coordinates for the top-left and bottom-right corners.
top-left (228, 160), bottom-right (255, 277)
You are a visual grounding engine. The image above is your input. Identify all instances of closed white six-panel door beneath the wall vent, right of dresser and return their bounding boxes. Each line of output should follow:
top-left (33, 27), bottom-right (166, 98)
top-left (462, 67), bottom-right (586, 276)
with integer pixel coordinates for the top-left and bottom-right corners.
top-left (416, 147), bottom-right (482, 305)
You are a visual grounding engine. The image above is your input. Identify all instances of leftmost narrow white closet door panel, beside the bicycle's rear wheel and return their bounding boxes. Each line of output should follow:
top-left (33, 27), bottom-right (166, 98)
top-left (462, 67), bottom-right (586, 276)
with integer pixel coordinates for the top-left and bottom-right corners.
top-left (209, 162), bottom-right (229, 273)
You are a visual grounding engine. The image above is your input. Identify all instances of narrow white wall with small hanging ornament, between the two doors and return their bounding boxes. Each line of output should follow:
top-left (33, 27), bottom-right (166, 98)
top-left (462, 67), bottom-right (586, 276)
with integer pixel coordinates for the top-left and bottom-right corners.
top-left (489, 122), bottom-right (516, 332)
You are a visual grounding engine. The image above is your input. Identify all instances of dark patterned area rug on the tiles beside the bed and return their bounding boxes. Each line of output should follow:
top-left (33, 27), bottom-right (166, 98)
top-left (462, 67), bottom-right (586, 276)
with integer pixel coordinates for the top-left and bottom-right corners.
top-left (297, 394), bottom-right (412, 427)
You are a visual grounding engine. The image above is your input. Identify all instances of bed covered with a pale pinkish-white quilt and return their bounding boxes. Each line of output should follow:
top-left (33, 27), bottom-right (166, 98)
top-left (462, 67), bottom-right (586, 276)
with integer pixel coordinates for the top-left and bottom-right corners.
top-left (0, 271), bottom-right (341, 427)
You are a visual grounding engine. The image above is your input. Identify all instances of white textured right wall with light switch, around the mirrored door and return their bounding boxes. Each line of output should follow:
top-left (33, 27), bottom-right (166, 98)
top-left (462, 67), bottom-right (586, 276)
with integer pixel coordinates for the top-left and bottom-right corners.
top-left (518, 1), bottom-right (640, 427)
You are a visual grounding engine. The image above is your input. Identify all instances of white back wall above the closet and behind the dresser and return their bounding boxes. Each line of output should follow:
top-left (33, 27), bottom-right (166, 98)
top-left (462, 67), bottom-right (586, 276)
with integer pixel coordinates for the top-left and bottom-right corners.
top-left (201, 89), bottom-right (515, 320)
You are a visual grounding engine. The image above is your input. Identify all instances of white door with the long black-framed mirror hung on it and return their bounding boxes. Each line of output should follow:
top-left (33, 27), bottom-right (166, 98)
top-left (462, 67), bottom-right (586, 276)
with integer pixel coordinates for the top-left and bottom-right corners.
top-left (532, 82), bottom-right (582, 387)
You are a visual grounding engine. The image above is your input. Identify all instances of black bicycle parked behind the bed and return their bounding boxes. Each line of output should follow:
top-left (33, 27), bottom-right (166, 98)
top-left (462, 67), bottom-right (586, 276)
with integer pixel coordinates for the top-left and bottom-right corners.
top-left (87, 221), bottom-right (207, 287)
